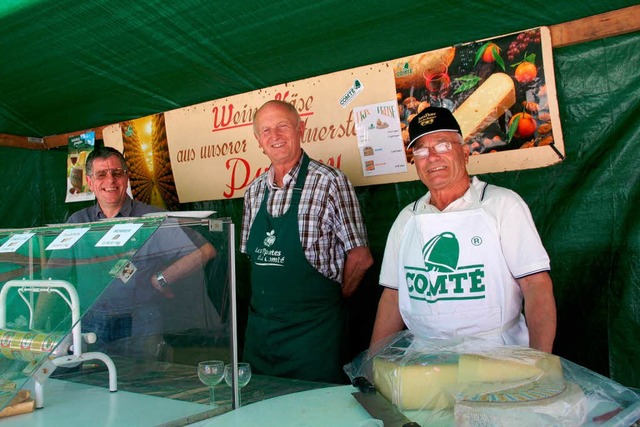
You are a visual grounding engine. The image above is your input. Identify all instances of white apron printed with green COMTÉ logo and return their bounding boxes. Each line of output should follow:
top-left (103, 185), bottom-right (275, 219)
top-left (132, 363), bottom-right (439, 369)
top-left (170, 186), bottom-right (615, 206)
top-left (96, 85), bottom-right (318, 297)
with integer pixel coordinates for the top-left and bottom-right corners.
top-left (398, 208), bottom-right (529, 346)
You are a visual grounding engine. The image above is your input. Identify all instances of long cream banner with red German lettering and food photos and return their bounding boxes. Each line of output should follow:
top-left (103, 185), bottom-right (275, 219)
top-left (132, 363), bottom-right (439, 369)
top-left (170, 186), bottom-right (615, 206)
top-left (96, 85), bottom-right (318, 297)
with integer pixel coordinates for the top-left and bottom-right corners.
top-left (103, 27), bottom-right (564, 204)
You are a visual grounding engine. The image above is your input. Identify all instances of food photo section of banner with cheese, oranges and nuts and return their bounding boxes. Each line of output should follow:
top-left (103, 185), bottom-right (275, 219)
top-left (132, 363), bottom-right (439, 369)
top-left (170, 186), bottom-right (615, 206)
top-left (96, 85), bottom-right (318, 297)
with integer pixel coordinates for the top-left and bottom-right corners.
top-left (394, 27), bottom-right (564, 174)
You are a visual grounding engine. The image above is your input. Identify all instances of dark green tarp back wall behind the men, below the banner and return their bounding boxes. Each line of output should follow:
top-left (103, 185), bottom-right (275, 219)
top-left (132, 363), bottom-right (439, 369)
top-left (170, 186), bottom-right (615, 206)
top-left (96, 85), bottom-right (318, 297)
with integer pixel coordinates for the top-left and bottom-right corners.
top-left (0, 12), bottom-right (640, 387)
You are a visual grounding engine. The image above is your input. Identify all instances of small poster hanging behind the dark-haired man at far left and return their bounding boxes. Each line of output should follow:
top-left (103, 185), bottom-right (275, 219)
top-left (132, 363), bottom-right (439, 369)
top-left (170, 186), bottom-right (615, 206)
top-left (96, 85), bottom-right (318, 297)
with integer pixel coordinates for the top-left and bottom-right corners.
top-left (65, 132), bottom-right (96, 203)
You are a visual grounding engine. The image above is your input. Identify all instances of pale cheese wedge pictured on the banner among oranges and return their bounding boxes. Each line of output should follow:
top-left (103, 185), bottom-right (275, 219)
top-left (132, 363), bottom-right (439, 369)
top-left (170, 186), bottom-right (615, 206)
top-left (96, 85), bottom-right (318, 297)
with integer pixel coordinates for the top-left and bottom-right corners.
top-left (453, 73), bottom-right (516, 141)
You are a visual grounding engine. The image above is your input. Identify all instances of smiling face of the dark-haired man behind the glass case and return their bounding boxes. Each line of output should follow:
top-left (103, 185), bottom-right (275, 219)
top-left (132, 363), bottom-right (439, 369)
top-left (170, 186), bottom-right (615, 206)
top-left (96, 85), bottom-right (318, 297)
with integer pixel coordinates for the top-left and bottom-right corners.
top-left (87, 156), bottom-right (129, 216)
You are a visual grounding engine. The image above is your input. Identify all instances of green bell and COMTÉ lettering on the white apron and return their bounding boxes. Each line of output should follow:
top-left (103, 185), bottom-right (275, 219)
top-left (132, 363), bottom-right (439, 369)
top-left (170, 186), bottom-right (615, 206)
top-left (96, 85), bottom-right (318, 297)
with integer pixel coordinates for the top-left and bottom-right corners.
top-left (404, 231), bottom-right (486, 303)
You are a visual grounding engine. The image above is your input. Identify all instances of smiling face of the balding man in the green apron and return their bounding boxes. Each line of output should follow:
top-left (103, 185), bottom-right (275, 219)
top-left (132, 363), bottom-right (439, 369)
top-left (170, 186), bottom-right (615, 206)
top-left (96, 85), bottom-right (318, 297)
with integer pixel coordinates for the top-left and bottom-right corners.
top-left (254, 102), bottom-right (304, 171)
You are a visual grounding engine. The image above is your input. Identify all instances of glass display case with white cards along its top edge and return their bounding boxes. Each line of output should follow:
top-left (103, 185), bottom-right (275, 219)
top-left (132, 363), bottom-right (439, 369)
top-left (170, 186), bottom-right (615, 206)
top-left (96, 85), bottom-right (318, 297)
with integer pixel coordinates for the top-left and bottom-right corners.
top-left (0, 213), bottom-right (238, 424)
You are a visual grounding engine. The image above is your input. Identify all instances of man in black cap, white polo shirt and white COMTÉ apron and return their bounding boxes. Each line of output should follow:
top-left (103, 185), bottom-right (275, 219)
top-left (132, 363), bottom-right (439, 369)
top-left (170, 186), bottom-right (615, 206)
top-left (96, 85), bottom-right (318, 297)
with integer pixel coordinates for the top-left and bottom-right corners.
top-left (371, 107), bottom-right (556, 352)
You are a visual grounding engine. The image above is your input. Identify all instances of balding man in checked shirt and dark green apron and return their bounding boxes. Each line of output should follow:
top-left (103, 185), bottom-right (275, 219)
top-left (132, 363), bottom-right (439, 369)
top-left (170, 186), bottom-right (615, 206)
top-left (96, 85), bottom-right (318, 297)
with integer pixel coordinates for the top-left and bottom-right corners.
top-left (240, 101), bottom-right (373, 383)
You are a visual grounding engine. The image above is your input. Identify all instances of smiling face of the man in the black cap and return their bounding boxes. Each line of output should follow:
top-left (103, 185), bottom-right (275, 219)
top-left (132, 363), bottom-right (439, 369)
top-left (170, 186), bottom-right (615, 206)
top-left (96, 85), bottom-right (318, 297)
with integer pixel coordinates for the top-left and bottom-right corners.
top-left (413, 132), bottom-right (469, 192)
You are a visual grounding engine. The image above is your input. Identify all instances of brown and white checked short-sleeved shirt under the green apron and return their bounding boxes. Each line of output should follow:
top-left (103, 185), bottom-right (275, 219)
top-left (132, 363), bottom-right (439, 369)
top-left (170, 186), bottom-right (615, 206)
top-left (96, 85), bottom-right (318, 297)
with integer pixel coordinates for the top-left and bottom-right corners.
top-left (240, 157), bottom-right (368, 283)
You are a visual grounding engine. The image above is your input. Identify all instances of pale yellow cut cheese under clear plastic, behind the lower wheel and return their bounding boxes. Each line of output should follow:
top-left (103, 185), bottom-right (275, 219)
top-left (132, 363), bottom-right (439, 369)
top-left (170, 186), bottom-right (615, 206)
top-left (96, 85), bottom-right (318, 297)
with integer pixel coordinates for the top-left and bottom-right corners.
top-left (373, 348), bottom-right (562, 410)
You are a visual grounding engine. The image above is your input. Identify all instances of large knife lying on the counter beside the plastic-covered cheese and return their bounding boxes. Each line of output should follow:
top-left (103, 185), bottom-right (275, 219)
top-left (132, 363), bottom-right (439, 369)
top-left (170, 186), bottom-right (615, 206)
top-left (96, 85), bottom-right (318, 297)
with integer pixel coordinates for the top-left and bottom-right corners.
top-left (351, 377), bottom-right (420, 427)
